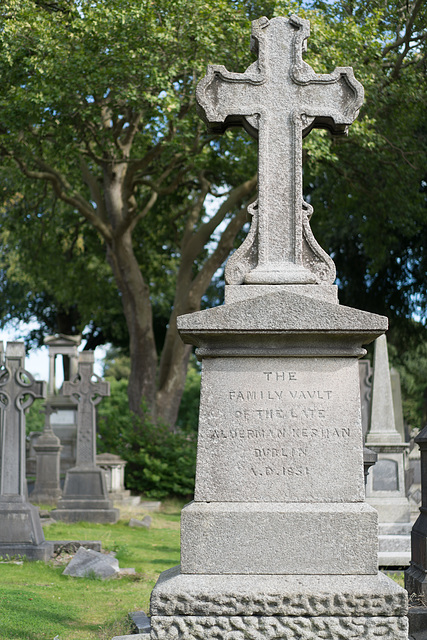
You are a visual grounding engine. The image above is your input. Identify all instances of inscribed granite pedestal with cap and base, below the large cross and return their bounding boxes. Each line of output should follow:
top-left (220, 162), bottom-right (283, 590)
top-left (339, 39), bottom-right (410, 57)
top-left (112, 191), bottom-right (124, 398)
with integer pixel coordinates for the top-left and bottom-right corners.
top-left (151, 286), bottom-right (408, 640)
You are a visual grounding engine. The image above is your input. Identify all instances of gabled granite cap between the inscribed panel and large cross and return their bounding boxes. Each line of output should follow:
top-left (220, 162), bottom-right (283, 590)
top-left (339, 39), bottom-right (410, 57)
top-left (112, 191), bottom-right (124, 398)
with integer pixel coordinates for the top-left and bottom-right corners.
top-left (177, 285), bottom-right (388, 356)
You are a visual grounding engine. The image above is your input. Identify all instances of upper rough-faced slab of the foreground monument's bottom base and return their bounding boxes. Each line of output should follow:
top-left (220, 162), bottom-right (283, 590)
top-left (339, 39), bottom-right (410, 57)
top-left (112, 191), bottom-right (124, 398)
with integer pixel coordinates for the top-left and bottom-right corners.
top-left (150, 566), bottom-right (408, 616)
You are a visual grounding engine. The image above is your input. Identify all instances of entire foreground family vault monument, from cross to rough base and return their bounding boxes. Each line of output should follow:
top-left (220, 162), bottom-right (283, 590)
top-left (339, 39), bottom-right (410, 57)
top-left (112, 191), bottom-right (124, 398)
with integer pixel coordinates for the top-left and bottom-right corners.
top-left (151, 16), bottom-right (408, 640)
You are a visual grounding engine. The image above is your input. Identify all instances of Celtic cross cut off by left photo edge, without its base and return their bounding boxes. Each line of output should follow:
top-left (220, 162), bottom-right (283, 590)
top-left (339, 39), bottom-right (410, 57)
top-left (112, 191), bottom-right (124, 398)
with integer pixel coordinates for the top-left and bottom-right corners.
top-left (0, 342), bottom-right (46, 500)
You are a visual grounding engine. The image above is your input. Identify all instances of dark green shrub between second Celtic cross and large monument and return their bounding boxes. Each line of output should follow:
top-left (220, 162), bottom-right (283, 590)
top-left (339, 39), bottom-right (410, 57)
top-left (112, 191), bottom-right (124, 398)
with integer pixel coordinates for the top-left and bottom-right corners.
top-left (97, 379), bottom-right (197, 499)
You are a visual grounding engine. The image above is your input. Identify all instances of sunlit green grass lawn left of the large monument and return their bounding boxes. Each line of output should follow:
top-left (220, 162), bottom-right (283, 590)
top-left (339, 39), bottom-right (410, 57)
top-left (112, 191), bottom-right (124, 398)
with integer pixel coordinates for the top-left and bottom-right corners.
top-left (0, 502), bottom-right (183, 640)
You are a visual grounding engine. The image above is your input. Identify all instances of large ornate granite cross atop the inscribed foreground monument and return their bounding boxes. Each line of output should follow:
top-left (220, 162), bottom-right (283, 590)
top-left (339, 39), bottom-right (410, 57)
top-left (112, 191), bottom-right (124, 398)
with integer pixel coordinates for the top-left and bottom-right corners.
top-left (196, 16), bottom-right (363, 284)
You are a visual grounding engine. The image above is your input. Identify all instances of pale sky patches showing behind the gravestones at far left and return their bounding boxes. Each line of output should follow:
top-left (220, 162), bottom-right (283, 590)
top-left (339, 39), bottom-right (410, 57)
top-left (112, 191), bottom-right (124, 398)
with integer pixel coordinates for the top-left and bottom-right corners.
top-left (0, 323), bottom-right (107, 384)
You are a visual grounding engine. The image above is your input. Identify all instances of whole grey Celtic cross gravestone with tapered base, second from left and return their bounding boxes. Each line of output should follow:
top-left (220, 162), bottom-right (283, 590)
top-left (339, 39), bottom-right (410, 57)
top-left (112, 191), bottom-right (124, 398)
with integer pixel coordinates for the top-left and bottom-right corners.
top-left (51, 351), bottom-right (119, 523)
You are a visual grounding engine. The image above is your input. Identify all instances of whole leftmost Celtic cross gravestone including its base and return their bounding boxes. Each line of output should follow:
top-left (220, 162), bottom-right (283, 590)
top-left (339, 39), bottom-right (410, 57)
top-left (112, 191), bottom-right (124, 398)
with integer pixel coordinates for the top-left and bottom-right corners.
top-left (0, 342), bottom-right (53, 560)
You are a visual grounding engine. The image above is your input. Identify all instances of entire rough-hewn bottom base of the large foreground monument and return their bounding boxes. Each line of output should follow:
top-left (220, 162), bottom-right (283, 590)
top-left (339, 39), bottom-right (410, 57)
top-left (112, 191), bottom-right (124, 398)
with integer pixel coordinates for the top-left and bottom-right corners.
top-left (150, 567), bottom-right (408, 640)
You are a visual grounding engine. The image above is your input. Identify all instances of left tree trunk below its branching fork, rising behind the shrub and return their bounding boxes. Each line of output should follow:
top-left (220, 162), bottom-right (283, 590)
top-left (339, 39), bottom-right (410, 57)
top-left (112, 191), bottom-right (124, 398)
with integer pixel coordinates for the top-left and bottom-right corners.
top-left (107, 230), bottom-right (157, 420)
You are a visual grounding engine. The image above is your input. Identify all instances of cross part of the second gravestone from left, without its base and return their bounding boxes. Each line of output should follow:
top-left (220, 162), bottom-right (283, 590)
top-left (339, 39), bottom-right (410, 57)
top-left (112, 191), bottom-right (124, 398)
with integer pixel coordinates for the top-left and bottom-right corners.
top-left (63, 351), bottom-right (110, 467)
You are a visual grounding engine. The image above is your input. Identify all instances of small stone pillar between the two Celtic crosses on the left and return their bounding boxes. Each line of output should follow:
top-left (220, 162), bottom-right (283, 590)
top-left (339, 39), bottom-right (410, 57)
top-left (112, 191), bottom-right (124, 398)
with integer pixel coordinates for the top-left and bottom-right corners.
top-left (30, 404), bottom-right (62, 505)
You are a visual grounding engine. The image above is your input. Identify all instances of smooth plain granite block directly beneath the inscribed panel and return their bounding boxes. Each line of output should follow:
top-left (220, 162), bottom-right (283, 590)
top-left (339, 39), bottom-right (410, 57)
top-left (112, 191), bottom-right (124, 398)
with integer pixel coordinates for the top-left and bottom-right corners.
top-left (181, 502), bottom-right (378, 575)
